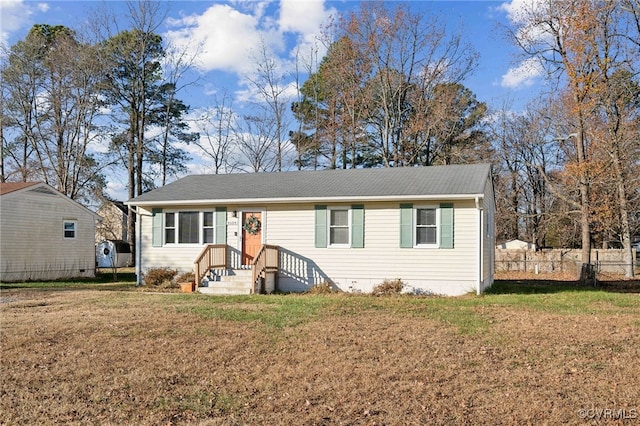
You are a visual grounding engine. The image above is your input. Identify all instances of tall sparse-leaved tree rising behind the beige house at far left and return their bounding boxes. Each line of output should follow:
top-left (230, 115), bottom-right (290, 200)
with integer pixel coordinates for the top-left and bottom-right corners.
top-left (2, 25), bottom-right (103, 200)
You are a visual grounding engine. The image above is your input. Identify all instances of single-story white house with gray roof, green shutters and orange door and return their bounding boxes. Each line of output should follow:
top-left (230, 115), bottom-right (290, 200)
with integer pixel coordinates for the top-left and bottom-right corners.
top-left (128, 164), bottom-right (495, 295)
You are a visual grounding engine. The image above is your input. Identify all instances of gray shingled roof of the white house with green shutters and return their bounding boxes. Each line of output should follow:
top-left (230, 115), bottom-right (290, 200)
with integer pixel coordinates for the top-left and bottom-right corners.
top-left (129, 164), bottom-right (490, 205)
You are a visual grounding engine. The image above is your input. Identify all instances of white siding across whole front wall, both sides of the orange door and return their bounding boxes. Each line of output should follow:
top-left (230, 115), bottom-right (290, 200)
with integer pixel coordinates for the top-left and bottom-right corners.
top-left (138, 199), bottom-right (488, 295)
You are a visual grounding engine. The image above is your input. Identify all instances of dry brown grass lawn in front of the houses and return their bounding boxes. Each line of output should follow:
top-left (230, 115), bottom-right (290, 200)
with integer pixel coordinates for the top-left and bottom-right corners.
top-left (0, 282), bottom-right (640, 425)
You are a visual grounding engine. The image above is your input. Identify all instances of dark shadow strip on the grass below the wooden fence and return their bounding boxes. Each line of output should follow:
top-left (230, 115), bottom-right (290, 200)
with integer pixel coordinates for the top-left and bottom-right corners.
top-left (486, 280), bottom-right (640, 294)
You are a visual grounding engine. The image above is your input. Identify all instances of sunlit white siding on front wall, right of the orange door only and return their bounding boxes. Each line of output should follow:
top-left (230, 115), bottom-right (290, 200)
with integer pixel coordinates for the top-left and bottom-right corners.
top-left (266, 201), bottom-right (477, 294)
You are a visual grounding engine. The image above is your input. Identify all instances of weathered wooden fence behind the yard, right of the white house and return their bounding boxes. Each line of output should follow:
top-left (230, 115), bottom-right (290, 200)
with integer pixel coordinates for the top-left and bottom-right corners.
top-left (495, 249), bottom-right (636, 274)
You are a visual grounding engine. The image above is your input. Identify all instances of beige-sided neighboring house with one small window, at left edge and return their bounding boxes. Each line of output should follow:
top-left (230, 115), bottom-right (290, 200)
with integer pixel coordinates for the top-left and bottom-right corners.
top-left (0, 182), bottom-right (99, 281)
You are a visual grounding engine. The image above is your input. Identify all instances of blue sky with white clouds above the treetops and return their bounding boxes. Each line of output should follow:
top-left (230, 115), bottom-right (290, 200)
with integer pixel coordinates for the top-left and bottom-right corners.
top-left (0, 0), bottom-right (543, 200)
